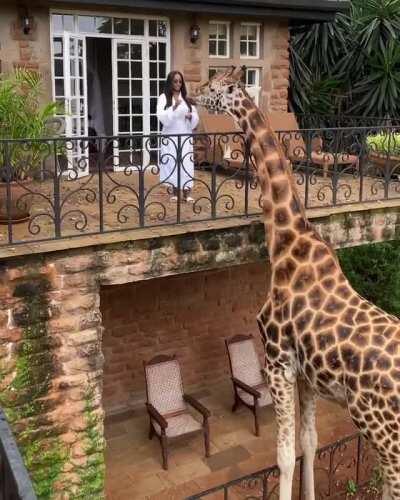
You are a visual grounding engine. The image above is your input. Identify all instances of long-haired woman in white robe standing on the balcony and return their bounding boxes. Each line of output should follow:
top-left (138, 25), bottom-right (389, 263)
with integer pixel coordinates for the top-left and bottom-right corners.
top-left (157, 71), bottom-right (199, 201)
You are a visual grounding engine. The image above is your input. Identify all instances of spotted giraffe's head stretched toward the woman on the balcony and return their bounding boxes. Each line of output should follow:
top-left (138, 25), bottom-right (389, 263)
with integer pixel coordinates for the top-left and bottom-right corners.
top-left (194, 66), bottom-right (249, 118)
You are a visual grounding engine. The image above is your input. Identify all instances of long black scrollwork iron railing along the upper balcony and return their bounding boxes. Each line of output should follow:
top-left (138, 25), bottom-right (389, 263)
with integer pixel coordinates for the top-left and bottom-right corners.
top-left (0, 126), bottom-right (400, 246)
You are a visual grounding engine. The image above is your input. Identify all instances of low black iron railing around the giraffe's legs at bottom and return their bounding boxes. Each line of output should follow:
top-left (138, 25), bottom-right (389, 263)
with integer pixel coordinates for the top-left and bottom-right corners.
top-left (186, 434), bottom-right (382, 500)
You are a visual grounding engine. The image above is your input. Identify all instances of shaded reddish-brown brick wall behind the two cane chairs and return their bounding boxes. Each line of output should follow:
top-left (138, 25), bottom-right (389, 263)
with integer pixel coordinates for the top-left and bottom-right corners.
top-left (101, 263), bottom-right (266, 412)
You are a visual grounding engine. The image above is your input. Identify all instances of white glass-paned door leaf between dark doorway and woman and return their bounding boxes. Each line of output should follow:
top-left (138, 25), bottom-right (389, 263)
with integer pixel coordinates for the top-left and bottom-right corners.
top-left (112, 39), bottom-right (150, 170)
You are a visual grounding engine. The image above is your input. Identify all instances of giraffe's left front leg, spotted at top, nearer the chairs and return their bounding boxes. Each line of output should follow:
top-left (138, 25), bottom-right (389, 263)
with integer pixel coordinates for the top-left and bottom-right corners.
top-left (266, 363), bottom-right (296, 500)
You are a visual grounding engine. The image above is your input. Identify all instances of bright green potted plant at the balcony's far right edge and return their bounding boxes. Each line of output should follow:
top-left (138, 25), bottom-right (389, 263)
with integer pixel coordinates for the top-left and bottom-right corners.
top-left (367, 131), bottom-right (400, 178)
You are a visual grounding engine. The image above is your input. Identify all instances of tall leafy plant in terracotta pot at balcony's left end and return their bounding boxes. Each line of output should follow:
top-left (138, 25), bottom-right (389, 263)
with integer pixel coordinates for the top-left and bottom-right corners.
top-left (0, 69), bottom-right (57, 224)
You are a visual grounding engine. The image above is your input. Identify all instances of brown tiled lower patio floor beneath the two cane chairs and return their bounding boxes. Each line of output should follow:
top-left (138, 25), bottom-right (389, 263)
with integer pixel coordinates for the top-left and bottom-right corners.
top-left (105, 381), bottom-right (356, 500)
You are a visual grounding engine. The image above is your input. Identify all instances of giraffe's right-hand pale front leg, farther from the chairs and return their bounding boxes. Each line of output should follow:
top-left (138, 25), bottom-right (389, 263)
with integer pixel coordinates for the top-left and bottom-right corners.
top-left (297, 378), bottom-right (318, 500)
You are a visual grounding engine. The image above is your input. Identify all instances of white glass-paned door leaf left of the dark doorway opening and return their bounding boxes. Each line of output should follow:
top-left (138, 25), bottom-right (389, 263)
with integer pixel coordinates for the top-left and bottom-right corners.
top-left (63, 32), bottom-right (89, 178)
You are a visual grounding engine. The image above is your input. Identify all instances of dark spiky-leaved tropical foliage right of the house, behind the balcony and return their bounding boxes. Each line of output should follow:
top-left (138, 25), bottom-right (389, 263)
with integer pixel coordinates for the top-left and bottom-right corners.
top-left (291, 0), bottom-right (400, 117)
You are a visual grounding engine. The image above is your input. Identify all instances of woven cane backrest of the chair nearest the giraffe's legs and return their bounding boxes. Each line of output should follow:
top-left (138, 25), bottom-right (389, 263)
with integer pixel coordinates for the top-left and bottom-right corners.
top-left (229, 339), bottom-right (264, 387)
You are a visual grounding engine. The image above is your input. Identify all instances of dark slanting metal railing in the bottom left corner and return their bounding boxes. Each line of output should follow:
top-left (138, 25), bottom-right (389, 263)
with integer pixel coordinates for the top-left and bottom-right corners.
top-left (0, 409), bottom-right (37, 500)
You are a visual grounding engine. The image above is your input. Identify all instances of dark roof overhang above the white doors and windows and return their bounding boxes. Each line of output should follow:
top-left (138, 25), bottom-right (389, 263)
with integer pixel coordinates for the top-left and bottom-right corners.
top-left (50, 0), bottom-right (350, 23)
